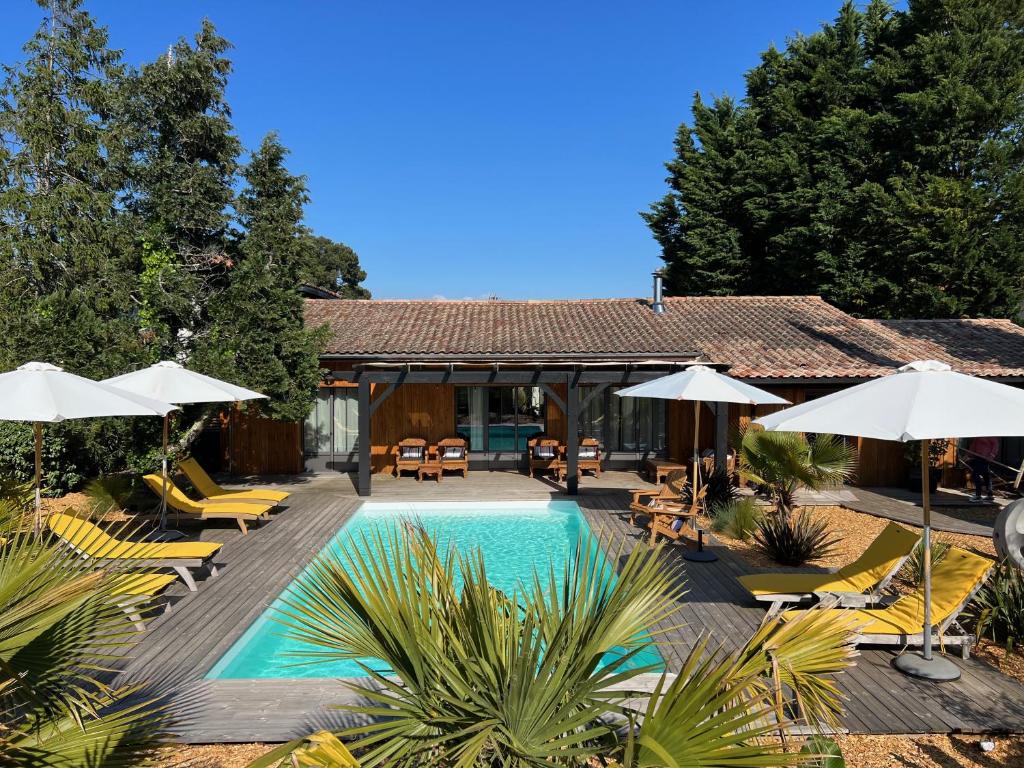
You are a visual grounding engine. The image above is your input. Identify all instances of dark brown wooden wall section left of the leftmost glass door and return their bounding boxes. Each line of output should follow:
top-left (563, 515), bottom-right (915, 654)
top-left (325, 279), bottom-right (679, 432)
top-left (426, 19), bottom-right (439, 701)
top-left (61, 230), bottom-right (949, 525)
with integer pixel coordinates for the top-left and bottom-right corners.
top-left (221, 409), bottom-right (305, 475)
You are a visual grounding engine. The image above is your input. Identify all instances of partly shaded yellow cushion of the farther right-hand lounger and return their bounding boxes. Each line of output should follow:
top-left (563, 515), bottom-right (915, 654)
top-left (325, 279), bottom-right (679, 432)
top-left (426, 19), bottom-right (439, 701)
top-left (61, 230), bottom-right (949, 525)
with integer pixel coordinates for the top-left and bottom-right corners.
top-left (738, 522), bottom-right (921, 596)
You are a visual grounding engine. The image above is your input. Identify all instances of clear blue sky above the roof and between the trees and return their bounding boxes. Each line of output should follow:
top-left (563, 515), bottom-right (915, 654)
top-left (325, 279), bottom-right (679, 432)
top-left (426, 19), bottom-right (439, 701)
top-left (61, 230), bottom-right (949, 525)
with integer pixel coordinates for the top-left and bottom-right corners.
top-left (0, 0), bottom-right (840, 298)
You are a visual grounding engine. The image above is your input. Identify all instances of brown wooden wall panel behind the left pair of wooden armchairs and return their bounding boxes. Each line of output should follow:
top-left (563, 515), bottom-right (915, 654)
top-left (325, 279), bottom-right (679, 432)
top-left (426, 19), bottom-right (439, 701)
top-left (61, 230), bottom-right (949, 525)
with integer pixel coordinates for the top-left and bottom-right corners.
top-left (370, 384), bottom-right (455, 472)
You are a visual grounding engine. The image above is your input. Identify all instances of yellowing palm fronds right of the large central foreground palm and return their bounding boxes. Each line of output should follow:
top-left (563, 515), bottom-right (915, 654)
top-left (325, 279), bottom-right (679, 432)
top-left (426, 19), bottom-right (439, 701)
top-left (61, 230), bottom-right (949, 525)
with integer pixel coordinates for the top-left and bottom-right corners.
top-left (616, 610), bottom-right (857, 768)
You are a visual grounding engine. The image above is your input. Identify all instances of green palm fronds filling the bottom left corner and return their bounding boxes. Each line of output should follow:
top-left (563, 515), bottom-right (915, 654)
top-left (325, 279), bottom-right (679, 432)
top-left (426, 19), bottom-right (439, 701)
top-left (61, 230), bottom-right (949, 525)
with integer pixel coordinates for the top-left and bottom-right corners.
top-left (0, 505), bottom-right (166, 768)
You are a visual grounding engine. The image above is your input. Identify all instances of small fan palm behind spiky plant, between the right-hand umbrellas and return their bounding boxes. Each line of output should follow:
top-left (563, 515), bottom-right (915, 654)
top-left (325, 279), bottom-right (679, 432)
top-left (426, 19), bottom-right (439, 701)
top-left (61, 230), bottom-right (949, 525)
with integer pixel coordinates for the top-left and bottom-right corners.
top-left (737, 427), bottom-right (857, 514)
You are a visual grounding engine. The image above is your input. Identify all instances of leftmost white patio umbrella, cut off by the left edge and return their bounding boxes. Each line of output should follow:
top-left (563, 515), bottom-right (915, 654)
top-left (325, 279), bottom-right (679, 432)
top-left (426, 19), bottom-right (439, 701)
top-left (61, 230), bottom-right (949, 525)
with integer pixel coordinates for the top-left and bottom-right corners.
top-left (0, 362), bottom-right (176, 532)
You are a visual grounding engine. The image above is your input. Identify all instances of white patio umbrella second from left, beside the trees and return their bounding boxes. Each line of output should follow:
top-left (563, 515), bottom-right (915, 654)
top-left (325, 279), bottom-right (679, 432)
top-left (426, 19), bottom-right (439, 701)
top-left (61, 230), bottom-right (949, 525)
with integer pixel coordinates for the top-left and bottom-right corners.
top-left (103, 360), bottom-right (266, 530)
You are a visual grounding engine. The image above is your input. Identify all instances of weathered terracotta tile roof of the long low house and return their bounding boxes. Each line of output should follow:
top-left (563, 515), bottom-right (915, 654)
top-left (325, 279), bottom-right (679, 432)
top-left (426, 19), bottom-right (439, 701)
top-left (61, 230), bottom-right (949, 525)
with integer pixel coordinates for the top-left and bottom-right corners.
top-left (306, 296), bottom-right (1024, 379)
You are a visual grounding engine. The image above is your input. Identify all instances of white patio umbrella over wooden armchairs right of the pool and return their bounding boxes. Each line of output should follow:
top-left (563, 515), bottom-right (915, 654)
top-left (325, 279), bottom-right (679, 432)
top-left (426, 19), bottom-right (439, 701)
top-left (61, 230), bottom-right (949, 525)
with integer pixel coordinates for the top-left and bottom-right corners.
top-left (615, 366), bottom-right (790, 560)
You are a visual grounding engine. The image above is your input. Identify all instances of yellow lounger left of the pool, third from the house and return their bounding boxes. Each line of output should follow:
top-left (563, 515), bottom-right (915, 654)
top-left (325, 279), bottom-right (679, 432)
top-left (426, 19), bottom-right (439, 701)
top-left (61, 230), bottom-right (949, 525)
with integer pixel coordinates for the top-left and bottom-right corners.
top-left (46, 512), bottom-right (223, 592)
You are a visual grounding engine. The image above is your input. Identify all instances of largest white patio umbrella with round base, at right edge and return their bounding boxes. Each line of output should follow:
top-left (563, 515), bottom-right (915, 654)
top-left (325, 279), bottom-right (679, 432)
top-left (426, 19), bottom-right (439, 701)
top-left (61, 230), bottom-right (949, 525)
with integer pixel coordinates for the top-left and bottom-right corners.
top-left (757, 360), bottom-right (1024, 680)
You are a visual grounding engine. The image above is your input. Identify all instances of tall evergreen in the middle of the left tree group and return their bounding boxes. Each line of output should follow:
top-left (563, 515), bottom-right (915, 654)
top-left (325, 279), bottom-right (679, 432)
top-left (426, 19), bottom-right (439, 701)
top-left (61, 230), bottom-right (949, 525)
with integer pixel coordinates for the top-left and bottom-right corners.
top-left (123, 20), bottom-right (241, 359)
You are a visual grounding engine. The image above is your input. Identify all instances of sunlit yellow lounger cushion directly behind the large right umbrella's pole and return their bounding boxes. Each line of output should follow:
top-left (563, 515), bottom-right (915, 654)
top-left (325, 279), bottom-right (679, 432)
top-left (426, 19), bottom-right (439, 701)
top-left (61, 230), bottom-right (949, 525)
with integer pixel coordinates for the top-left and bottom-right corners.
top-left (782, 547), bottom-right (994, 635)
